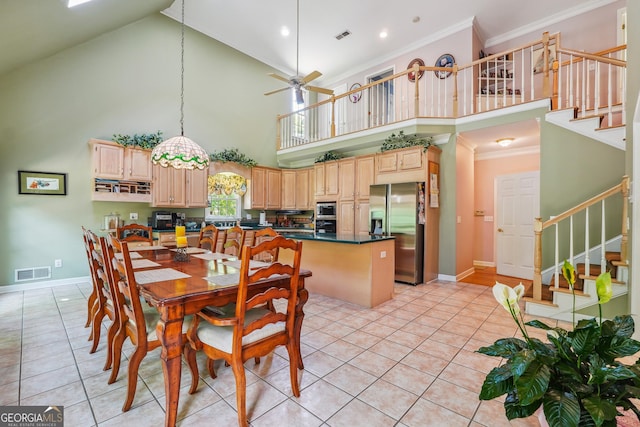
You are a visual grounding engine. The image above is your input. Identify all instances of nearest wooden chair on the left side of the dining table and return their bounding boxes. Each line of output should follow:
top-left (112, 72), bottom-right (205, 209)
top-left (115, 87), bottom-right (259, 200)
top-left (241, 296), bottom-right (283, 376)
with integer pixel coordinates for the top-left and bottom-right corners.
top-left (105, 235), bottom-right (191, 412)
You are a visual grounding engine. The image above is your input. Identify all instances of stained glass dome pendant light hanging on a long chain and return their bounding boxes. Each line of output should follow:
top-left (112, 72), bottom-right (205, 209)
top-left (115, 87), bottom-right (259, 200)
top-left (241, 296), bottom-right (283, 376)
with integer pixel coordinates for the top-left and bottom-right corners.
top-left (151, 0), bottom-right (209, 169)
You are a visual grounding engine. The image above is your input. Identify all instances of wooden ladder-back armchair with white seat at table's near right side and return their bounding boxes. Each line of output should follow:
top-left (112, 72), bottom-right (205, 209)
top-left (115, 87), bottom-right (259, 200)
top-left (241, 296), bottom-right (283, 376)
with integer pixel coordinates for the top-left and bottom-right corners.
top-left (185, 236), bottom-right (302, 427)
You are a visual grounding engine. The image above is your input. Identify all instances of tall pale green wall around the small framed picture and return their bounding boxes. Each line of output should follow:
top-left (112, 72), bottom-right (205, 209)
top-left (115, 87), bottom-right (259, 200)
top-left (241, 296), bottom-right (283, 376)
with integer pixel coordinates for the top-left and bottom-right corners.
top-left (0, 14), bottom-right (288, 285)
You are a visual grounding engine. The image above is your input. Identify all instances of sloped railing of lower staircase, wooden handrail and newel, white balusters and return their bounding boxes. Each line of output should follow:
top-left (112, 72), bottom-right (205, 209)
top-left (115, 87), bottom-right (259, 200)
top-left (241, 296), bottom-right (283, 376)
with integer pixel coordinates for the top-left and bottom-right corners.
top-left (533, 175), bottom-right (629, 301)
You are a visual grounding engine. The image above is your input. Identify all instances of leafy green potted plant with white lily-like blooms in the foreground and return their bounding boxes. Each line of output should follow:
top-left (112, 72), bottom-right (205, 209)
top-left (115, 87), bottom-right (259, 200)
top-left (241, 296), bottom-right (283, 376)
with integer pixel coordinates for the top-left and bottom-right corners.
top-left (477, 261), bottom-right (640, 427)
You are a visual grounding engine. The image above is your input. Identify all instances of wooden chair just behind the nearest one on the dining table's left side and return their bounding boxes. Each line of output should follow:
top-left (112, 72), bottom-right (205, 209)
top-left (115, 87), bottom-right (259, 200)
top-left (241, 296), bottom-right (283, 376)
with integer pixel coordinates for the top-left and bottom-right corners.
top-left (86, 230), bottom-right (121, 371)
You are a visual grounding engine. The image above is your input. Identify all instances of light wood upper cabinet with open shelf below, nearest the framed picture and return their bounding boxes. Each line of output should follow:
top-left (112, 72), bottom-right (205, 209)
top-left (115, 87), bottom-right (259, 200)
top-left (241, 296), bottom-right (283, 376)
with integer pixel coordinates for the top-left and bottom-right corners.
top-left (89, 139), bottom-right (152, 203)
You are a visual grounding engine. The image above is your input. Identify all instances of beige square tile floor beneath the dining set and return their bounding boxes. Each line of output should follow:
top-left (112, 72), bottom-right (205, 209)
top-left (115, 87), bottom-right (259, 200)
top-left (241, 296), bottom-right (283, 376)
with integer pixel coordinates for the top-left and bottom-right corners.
top-left (0, 282), bottom-right (560, 427)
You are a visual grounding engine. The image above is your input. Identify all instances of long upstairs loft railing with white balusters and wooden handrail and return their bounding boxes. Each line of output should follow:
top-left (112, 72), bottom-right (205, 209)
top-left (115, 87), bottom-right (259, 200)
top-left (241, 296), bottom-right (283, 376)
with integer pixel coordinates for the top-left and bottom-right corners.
top-left (277, 33), bottom-right (626, 150)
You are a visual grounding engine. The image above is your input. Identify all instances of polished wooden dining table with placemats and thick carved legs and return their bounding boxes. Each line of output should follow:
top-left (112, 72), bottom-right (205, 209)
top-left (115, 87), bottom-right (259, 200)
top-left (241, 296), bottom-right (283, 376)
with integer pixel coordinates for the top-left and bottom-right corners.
top-left (130, 247), bottom-right (311, 427)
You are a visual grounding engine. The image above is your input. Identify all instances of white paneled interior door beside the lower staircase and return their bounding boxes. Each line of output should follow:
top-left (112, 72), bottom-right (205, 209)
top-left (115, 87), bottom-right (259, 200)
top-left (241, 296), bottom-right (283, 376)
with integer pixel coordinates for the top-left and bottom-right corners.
top-left (495, 171), bottom-right (540, 280)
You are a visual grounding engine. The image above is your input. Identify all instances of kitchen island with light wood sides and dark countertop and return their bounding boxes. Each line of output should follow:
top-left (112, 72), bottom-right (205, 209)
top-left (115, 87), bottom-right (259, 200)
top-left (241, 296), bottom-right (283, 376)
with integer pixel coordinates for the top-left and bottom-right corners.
top-left (281, 233), bottom-right (395, 307)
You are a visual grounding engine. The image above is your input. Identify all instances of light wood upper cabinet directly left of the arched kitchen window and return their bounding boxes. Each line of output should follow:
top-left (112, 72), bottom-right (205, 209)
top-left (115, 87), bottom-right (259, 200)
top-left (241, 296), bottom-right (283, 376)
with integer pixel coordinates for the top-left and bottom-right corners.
top-left (152, 165), bottom-right (209, 208)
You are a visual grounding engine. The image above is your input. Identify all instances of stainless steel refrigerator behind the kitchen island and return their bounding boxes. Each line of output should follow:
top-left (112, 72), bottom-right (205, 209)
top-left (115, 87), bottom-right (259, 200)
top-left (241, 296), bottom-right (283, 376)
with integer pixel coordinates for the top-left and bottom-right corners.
top-left (369, 182), bottom-right (425, 285)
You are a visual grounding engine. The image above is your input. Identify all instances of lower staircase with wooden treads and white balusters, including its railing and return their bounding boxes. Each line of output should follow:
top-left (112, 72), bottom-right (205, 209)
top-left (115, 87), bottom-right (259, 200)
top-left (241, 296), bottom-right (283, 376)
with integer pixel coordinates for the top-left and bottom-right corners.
top-left (524, 176), bottom-right (629, 321)
